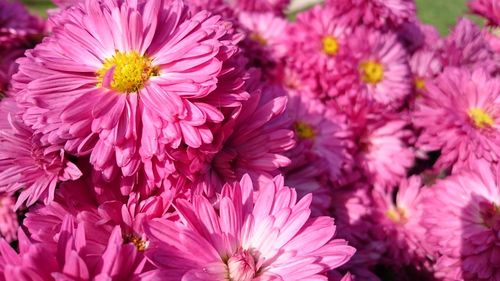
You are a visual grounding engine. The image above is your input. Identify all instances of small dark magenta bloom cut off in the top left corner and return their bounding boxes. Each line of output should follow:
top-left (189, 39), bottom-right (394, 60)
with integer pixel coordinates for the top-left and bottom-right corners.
top-left (0, 0), bottom-right (44, 50)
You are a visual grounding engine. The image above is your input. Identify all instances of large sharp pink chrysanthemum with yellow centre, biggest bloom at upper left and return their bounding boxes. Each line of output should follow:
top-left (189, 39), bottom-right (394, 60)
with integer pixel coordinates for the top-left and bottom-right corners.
top-left (13, 0), bottom-right (247, 190)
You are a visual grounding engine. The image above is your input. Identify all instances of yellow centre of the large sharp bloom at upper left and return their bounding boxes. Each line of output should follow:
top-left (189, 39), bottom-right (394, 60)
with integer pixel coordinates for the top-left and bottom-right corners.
top-left (97, 52), bottom-right (159, 93)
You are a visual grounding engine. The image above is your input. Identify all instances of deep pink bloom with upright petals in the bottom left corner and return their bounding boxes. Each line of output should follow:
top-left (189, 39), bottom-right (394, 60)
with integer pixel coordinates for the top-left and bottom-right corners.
top-left (0, 216), bottom-right (149, 281)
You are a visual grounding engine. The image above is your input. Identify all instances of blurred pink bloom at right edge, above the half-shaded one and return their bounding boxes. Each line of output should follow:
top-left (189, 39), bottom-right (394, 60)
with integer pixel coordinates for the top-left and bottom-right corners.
top-left (413, 69), bottom-right (500, 171)
